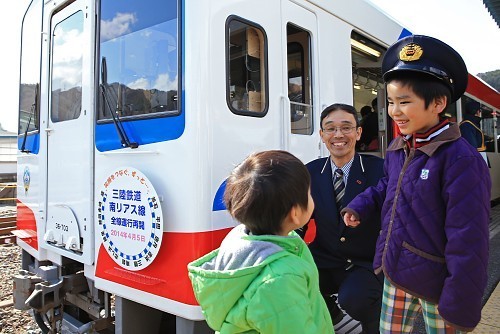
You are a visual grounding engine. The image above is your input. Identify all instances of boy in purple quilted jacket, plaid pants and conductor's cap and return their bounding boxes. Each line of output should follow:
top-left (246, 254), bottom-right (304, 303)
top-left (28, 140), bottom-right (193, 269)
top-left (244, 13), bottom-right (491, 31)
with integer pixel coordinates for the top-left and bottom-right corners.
top-left (342, 35), bottom-right (491, 333)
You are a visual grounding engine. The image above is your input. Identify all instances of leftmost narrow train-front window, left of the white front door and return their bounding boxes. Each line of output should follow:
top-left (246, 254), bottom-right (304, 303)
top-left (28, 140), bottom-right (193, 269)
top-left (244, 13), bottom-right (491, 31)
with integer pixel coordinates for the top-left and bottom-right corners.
top-left (19, 0), bottom-right (43, 135)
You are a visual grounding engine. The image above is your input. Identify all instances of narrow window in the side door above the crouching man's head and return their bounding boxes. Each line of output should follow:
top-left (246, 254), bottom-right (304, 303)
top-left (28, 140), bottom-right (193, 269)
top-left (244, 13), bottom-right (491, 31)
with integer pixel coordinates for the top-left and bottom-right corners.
top-left (287, 24), bottom-right (313, 135)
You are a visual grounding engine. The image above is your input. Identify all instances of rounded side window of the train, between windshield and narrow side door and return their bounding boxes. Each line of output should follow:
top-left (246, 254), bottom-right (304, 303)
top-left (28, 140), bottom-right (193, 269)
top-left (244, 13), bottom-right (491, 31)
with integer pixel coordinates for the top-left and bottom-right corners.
top-left (226, 17), bottom-right (268, 116)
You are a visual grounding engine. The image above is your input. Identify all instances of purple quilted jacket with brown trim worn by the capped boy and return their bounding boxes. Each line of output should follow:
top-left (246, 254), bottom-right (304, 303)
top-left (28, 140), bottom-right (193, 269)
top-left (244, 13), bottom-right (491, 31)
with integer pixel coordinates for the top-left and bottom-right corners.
top-left (344, 124), bottom-right (491, 331)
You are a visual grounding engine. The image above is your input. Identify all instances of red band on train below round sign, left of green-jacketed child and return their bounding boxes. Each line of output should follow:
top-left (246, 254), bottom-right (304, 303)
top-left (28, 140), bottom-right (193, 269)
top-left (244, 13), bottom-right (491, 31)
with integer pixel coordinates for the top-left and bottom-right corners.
top-left (95, 228), bottom-right (231, 305)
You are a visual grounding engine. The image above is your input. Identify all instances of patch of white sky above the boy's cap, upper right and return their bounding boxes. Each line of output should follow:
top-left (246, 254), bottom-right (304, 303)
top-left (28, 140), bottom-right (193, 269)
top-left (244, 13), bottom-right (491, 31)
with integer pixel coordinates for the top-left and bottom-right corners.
top-left (369, 0), bottom-right (500, 74)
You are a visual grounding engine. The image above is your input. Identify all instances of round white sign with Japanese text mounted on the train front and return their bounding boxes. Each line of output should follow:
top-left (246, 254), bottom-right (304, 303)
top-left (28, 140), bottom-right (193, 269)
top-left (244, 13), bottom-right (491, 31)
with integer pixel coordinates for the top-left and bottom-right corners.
top-left (97, 167), bottom-right (163, 271)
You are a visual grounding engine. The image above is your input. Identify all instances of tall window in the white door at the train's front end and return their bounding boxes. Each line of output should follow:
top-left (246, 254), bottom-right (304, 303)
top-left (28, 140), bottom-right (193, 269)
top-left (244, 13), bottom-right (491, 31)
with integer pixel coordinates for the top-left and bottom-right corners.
top-left (50, 11), bottom-right (83, 122)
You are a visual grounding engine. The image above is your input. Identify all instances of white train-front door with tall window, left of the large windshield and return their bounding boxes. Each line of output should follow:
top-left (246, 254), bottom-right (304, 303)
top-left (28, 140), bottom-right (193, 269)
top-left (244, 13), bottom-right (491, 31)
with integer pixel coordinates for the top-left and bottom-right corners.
top-left (44, 1), bottom-right (94, 264)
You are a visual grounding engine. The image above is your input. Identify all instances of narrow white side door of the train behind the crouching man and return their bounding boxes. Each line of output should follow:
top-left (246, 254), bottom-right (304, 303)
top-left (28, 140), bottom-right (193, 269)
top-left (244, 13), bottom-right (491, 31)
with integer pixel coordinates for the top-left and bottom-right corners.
top-left (282, 1), bottom-right (320, 162)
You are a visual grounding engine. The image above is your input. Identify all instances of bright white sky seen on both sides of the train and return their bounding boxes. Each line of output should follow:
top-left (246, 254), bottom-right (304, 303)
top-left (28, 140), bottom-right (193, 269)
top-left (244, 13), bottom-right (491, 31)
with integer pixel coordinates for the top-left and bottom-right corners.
top-left (0, 0), bottom-right (500, 132)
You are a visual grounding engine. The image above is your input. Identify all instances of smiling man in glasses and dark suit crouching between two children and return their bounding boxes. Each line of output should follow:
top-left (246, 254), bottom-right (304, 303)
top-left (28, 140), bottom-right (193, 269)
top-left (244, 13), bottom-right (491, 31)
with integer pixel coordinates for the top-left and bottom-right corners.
top-left (299, 104), bottom-right (383, 333)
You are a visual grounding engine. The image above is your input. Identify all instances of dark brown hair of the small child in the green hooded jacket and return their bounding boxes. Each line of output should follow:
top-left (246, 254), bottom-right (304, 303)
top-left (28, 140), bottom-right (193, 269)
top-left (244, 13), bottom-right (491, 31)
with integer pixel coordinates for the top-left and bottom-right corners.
top-left (224, 150), bottom-right (311, 235)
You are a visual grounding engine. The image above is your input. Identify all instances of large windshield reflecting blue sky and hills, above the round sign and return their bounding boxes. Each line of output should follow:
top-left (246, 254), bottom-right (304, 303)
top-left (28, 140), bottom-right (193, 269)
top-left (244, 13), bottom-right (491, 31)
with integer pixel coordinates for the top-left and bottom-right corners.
top-left (97, 0), bottom-right (180, 120)
